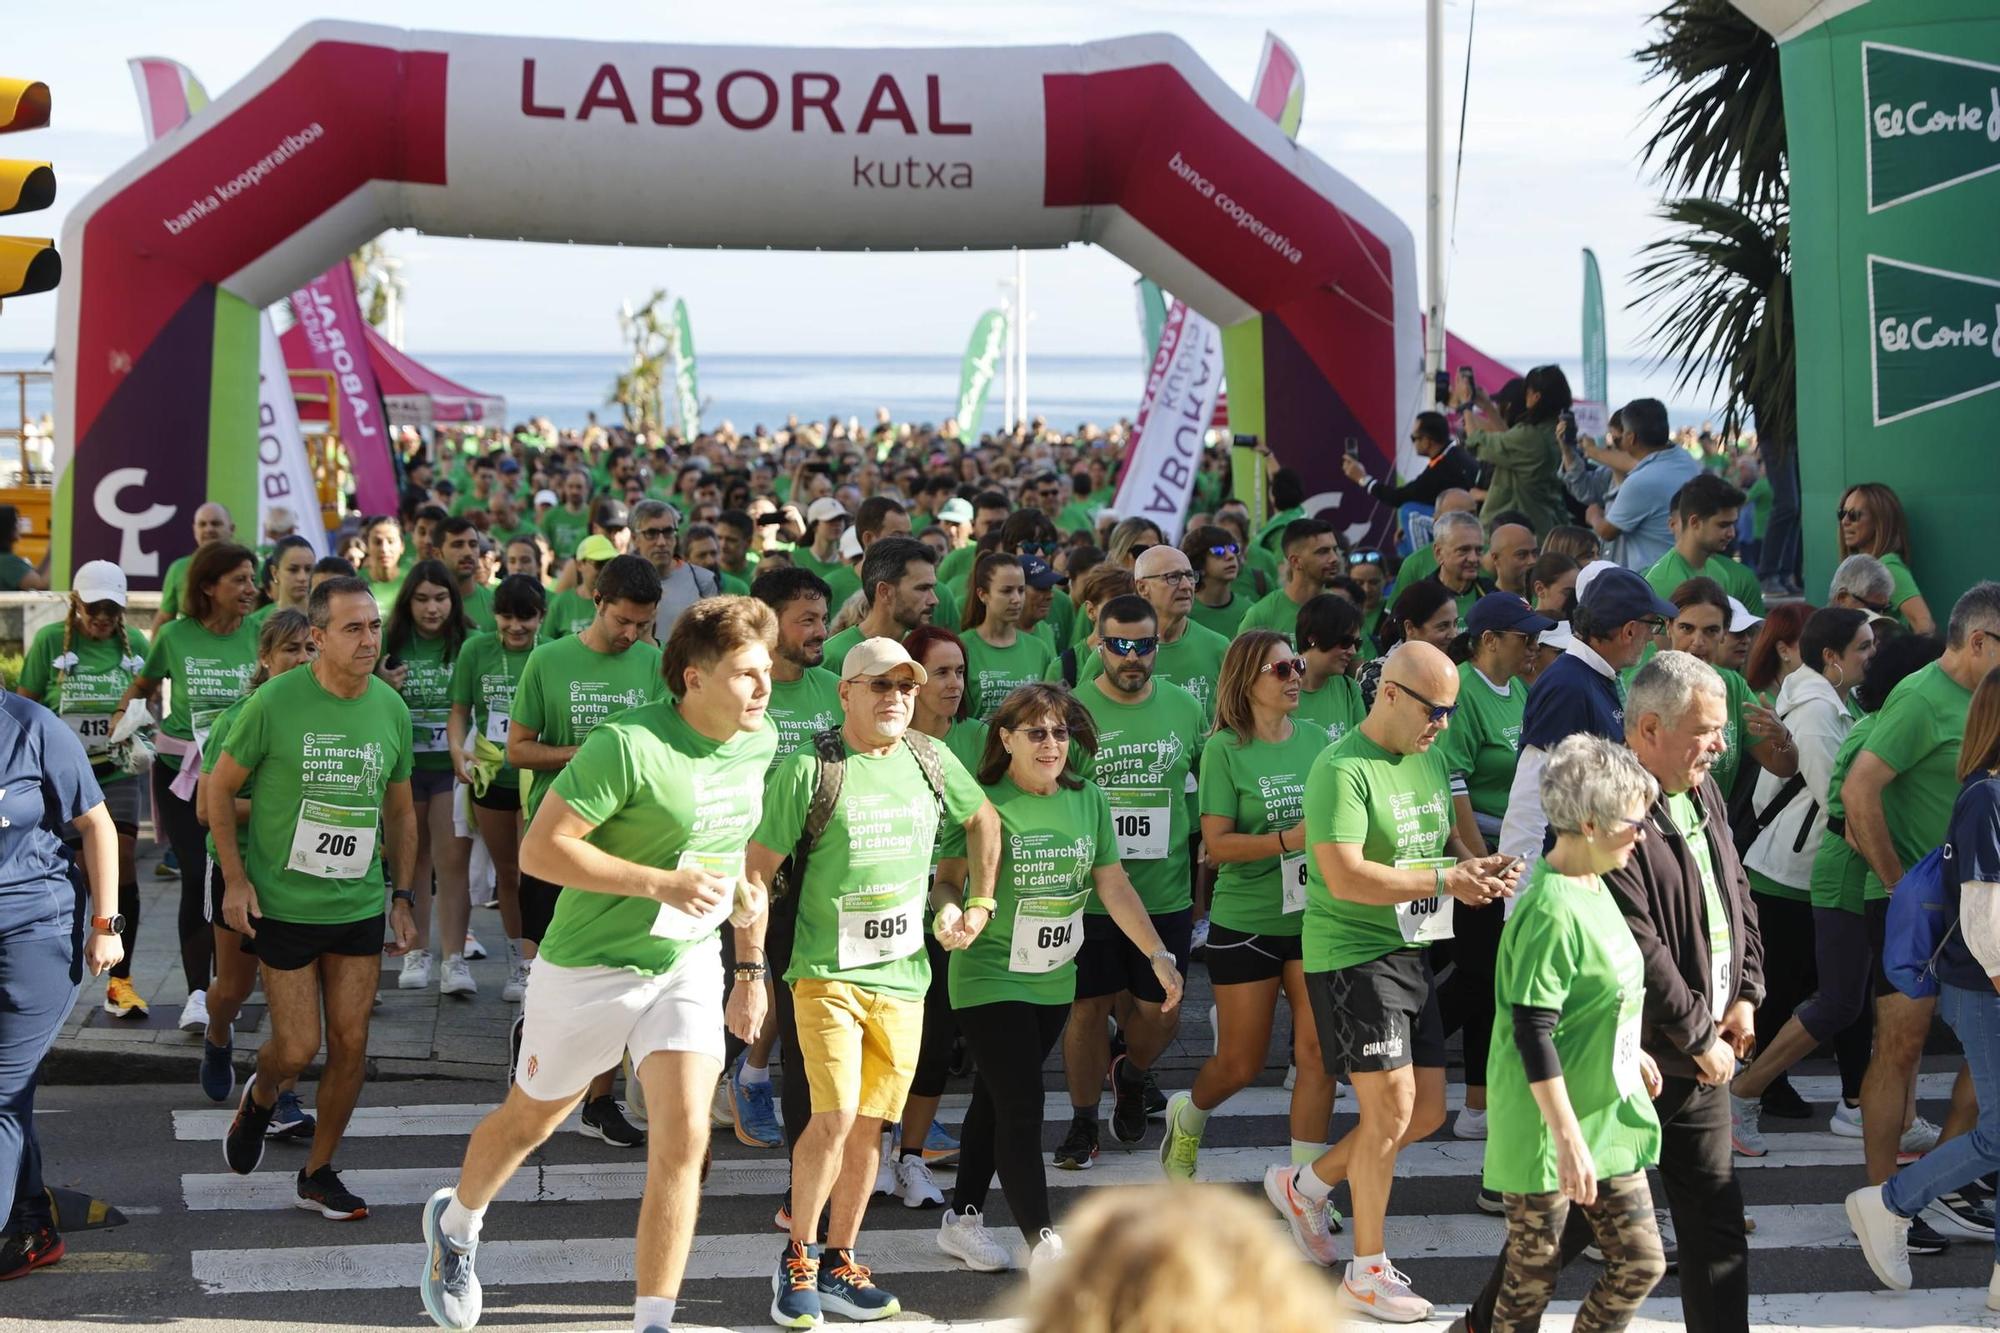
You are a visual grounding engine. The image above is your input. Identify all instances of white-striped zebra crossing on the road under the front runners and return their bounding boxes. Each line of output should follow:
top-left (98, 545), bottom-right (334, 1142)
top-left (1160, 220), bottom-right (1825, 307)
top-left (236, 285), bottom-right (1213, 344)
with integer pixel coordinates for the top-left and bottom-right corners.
top-left (162, 1073), bottom-right (2000, 1333)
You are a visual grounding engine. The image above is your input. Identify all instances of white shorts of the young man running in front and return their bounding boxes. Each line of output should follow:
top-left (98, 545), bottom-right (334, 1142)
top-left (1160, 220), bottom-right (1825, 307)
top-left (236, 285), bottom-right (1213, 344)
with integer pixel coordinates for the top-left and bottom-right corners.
top-left (514, 939), bottom-right (722, 1101)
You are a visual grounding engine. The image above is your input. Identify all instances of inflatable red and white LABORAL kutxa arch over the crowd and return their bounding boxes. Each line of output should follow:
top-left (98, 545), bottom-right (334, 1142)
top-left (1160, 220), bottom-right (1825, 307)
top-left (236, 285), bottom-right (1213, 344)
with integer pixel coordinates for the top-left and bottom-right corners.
top-left (56, 22), bottom-right (1420, 586)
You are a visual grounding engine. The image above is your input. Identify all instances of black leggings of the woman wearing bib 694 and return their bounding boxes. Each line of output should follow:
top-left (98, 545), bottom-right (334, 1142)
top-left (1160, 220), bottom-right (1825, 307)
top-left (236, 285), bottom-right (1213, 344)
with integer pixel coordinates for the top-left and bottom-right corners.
top-left (952, 1001), bottom-right (1070, 1245)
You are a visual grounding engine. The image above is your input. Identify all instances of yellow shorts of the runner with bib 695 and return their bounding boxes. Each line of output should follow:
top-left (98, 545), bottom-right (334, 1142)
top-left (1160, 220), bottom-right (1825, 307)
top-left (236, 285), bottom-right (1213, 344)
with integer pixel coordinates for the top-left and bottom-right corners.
top-left (792, 977), bottom-right (924, 1121)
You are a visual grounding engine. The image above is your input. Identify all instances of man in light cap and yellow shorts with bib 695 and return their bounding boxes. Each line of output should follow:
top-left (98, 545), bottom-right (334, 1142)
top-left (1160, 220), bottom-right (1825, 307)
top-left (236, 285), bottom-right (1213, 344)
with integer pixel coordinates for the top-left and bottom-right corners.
top-left (748, 638), bottom-right (1000, 1329)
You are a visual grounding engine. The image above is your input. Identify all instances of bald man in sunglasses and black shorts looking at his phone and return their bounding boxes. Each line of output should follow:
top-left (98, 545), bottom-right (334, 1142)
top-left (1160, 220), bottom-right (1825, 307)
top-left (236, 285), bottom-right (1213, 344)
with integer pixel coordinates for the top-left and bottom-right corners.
top-left (1264, 642), bottom-right (1518, 1323)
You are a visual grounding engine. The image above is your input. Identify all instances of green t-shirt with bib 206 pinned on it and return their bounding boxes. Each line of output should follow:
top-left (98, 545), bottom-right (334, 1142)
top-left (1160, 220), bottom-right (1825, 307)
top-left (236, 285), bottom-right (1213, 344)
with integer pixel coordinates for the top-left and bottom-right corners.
top-left (219, 664), bottom-right (410, 925)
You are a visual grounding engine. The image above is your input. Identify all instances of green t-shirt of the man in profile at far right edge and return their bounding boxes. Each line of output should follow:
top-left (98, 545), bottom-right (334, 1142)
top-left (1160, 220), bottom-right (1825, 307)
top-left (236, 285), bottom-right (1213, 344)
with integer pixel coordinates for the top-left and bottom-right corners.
top-left (1862, 662), bottom-right (1972, 897)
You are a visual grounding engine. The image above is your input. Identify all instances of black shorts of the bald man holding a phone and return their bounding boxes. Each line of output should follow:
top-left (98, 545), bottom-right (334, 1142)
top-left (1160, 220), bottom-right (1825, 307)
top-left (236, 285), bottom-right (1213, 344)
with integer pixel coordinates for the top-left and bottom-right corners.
top-left (1306, 949), bottom-right (1444, 1079)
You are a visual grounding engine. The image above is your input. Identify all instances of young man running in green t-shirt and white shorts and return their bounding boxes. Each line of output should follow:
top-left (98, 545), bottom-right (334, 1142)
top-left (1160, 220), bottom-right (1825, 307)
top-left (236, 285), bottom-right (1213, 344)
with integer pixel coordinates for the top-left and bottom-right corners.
top-left (420, 592), bottom-right (778, 1333)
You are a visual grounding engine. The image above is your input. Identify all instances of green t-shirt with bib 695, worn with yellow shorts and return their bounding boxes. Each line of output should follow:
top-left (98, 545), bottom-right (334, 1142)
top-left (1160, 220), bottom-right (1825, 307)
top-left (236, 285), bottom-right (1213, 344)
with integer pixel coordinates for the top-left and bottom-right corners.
top-left (754, 745), bottom-right (986, 1001)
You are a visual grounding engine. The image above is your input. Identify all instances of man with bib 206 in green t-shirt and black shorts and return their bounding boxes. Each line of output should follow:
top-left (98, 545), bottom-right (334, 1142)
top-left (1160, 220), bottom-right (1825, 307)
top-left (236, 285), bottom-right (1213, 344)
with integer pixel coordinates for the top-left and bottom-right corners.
top-left (208, 578), bottom-right (416, 1221)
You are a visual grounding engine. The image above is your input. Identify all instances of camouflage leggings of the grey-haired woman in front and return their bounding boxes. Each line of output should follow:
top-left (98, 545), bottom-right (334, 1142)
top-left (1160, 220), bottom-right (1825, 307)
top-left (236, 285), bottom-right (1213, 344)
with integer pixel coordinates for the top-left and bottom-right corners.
top-left (1490, 1171), bottom-right (1666, 1333)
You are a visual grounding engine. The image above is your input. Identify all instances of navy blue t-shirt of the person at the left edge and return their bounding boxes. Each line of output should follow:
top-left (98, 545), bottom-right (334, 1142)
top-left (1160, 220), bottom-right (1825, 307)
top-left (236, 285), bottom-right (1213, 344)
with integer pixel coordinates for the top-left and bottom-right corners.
top-left (0, 693), bottom-right (104, 935)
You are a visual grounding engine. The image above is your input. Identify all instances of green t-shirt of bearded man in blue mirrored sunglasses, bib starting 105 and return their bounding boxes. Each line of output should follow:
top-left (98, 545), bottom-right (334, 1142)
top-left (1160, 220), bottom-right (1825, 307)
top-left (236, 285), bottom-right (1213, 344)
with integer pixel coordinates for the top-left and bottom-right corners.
top-left (1076, 679), bottom-right (1208, 917)
